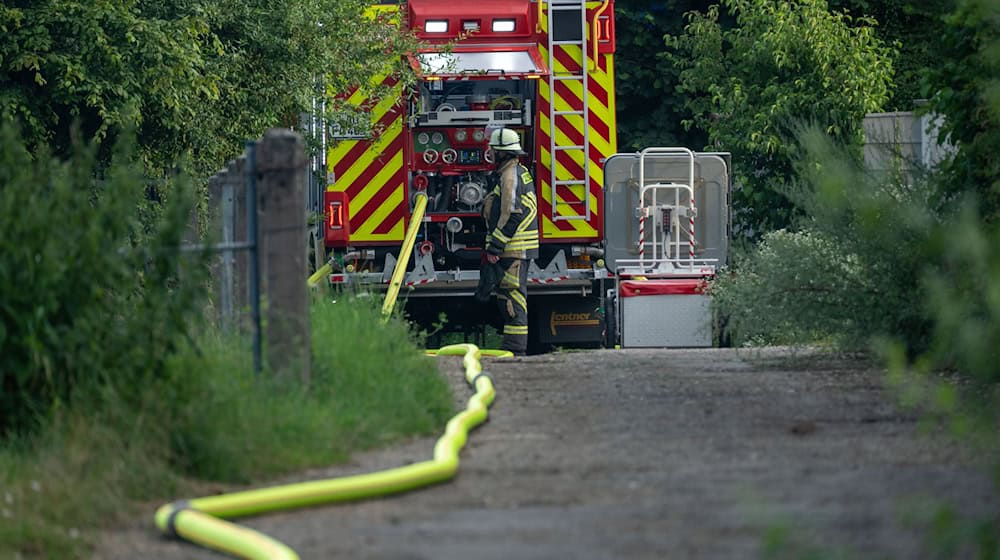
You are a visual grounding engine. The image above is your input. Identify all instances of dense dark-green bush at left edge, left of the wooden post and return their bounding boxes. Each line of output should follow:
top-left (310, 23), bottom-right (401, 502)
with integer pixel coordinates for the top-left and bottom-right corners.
top-left (0, 125), bottom-right (204, 435)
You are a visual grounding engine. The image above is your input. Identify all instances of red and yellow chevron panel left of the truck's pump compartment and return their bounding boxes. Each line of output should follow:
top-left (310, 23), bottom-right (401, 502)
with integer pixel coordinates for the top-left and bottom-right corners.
top-left (327, 80), bottom-right (409, 243)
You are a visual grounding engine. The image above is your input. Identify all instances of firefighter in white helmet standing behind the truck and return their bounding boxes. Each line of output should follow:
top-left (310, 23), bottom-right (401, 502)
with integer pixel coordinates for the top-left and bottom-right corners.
top-left (483, 128), bottom-right (538, 355)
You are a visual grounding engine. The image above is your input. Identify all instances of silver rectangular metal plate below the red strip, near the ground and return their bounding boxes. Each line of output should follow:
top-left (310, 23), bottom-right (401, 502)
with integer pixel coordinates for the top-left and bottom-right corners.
top-left (621, 295), bottom-right (712, 348)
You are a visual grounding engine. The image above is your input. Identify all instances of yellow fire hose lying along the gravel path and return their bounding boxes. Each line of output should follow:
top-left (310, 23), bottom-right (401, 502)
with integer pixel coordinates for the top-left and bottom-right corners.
top-left (156, 344), bottom-right (511, 560)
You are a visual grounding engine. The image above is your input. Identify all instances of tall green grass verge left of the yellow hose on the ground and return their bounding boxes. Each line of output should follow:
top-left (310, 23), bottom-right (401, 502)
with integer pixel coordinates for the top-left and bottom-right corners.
top-left (0, 270), bottom-right (453, 558)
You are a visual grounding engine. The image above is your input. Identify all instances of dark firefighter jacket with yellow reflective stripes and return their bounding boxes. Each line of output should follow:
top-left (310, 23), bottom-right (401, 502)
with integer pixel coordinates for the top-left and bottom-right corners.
top-left (483, 158), bottom-right (538, 259)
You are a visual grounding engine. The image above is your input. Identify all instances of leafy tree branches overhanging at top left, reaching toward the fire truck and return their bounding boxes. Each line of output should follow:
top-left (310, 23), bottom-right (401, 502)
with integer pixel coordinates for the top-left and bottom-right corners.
top-left (0, 0), bottom-right (413, 174)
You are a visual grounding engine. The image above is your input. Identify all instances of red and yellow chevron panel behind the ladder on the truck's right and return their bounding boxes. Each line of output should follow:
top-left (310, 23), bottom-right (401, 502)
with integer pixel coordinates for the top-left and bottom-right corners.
top-left (536, 2), bottom-right (618, 241)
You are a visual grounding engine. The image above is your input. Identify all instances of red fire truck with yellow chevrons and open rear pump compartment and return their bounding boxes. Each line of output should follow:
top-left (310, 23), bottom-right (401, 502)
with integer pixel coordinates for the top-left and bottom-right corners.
top-left (320, 0), bottom-right (728, 349)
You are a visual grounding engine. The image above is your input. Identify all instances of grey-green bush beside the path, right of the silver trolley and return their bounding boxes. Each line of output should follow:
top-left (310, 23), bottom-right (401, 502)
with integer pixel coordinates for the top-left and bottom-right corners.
top-left (713, 129), bottom-right (946, 354)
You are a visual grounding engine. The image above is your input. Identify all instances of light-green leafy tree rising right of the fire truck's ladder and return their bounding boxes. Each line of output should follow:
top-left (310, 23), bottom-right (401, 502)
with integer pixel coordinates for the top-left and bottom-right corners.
top-left (668, 0), bottom-right (892, 235)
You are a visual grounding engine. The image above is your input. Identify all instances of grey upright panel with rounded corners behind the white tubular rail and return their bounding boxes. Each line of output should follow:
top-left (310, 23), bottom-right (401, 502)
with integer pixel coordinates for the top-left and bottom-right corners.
top-left (604, 153), bottom-right (731, 272)
